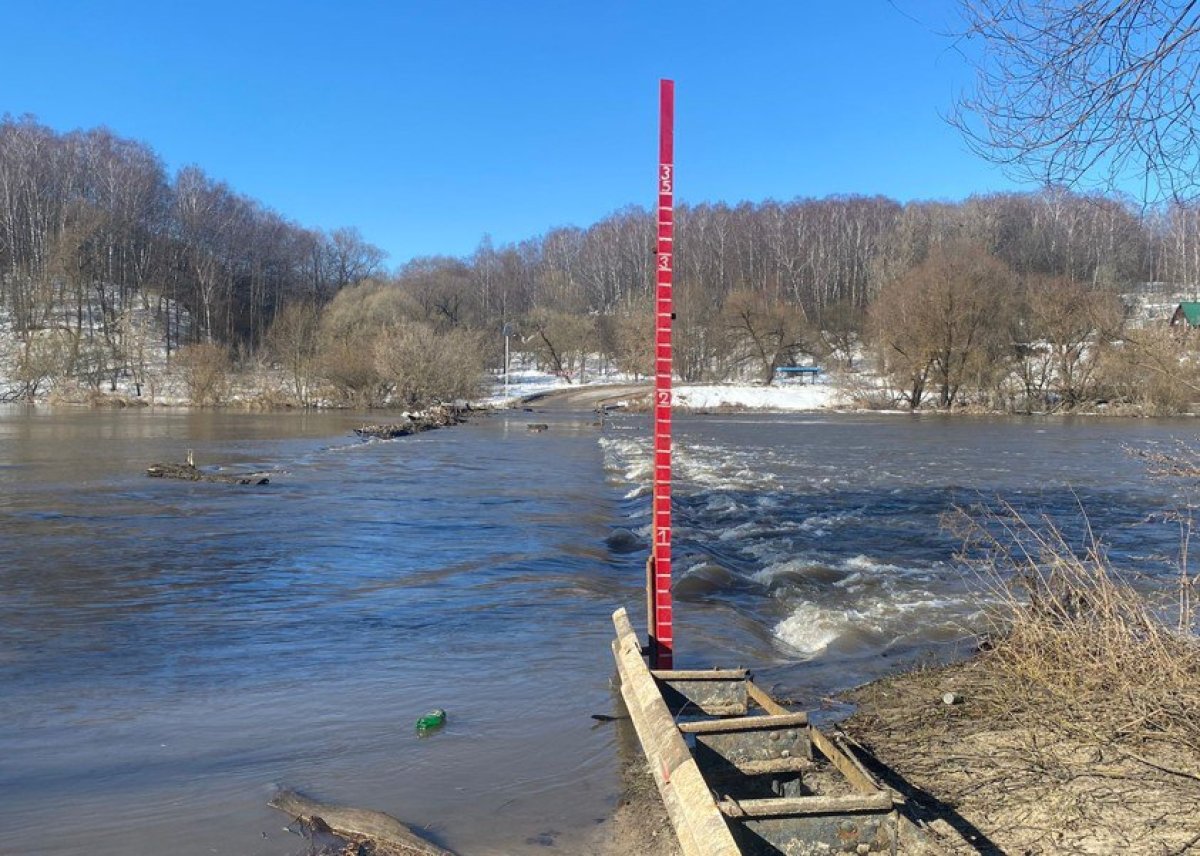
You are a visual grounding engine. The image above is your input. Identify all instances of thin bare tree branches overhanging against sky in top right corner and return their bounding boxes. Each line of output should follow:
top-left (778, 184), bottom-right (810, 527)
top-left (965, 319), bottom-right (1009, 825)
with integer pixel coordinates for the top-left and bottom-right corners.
top-left (953, 0), bottom-right (1200, 199)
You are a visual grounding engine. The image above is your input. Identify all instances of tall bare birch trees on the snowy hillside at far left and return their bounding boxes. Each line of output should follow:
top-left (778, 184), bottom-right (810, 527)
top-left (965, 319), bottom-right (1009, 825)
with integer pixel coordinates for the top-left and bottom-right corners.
top-left (0, 115), bottom-right (383, 396)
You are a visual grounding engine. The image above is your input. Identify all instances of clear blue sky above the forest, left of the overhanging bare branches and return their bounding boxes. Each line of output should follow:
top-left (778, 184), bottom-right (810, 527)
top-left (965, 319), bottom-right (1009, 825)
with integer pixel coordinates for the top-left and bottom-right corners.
top-left (0, 0), bottom-right (1013, 265)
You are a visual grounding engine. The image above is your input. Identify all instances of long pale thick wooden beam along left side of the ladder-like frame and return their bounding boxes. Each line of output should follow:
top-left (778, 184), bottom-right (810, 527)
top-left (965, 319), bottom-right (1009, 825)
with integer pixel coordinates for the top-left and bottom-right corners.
top-left (612, 609), bottom-right (740, 856)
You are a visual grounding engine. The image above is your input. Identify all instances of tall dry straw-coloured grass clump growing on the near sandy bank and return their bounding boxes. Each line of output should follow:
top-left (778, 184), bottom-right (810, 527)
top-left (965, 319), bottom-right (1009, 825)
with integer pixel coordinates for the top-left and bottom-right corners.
top-left (959, 505), bottom-right (1200, 758)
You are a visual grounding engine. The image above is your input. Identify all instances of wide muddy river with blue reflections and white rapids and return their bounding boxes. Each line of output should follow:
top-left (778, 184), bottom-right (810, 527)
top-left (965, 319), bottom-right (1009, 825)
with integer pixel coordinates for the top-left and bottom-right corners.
top-left (0, 408), bottom-right (1196, 856)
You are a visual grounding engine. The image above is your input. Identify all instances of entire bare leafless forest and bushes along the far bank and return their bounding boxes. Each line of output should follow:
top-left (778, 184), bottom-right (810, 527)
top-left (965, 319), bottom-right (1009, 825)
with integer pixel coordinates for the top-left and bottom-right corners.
top-left (7, 116), bottom-right (1200, 412)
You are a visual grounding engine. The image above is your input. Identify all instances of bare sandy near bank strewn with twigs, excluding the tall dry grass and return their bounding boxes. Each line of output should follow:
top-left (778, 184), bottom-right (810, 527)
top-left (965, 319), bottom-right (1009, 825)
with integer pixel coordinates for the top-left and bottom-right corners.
top-left (841, 658), bottom-right (1200, 856)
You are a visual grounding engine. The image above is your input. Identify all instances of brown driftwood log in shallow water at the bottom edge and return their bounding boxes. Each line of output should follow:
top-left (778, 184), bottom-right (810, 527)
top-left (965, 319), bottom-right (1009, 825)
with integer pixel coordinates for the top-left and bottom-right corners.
top-left (268, 789), bottom-right (455, 856)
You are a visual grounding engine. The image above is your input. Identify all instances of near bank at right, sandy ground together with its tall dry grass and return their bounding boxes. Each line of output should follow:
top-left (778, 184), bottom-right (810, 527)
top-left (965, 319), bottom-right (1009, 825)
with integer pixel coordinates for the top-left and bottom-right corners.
top-left (846, 507), bottom-right (1200, 854)
